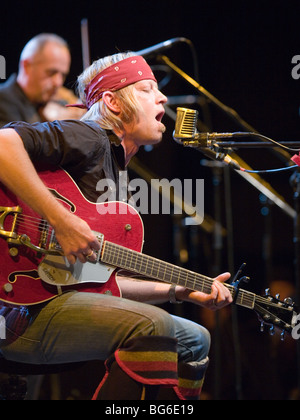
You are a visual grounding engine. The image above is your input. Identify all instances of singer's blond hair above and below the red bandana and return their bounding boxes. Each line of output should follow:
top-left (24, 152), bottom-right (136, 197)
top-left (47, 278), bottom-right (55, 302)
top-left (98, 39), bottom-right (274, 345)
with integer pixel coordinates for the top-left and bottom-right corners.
top-left (77, 52), bottom-right (140, 130)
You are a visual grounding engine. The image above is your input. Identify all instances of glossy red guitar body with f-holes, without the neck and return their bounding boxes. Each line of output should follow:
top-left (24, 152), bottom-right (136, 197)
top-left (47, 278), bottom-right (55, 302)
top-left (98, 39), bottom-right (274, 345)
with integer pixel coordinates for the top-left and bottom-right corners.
top-left (0, 170), bottom-right (144, 306)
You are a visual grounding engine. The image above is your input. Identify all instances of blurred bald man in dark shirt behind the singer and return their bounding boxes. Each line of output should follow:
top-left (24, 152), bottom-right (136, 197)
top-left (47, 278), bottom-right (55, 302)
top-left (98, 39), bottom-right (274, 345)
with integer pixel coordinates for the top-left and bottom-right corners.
top-left (0, 34), bottom-right (75, 126)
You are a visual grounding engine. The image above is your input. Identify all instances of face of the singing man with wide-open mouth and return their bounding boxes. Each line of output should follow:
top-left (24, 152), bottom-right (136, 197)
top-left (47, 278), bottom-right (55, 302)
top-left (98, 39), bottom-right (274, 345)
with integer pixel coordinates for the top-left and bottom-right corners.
top-left (126, 80), bottom-right (167, 146)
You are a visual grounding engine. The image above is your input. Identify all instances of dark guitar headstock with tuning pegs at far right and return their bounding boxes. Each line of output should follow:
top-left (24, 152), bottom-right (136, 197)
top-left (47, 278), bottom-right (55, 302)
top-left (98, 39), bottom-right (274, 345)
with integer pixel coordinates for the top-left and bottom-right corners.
top-left (254, 289), bottom-right (299, 340)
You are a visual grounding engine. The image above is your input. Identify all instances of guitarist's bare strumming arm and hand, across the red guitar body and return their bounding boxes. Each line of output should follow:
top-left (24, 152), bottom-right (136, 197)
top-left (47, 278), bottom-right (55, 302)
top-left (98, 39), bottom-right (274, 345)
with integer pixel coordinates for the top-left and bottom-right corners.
top-left (0, 129), bottom-right (99, 263)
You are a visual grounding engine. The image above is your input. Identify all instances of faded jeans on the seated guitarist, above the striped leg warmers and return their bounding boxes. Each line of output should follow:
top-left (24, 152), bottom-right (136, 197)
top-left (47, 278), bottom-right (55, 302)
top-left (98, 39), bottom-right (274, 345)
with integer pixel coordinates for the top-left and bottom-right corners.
top-left (0, 292), bottom-right (210, 364)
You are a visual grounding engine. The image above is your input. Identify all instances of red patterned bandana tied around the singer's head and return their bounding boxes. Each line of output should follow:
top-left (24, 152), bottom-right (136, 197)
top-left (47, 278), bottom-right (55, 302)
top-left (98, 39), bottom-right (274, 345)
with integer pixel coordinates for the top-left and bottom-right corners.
top-left (69, 56), bottom-right (157, 109)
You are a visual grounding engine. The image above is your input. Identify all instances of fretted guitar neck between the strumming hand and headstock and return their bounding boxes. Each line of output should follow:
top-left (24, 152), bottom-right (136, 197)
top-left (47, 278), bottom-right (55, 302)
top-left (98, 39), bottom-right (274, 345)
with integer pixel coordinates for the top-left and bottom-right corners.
top-left (101, 242), bottom-right (256, 309)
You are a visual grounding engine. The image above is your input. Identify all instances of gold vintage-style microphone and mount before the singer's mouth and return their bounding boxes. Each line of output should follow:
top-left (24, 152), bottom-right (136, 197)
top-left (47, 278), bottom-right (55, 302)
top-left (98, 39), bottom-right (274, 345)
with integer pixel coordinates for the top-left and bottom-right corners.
top-left (173, 108), bottom-right (244, 170)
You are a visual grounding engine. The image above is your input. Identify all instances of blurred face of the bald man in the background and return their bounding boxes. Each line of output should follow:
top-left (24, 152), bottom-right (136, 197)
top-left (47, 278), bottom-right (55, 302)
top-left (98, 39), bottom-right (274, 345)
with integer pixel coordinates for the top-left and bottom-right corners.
top-left (24, 42), bottom-right (71, 103)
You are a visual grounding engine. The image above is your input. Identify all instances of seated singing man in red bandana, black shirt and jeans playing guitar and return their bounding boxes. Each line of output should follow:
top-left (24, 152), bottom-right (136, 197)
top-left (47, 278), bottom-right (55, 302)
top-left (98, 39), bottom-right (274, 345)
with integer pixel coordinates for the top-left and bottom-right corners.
top-left (0, 53), bottom-right (232, 400)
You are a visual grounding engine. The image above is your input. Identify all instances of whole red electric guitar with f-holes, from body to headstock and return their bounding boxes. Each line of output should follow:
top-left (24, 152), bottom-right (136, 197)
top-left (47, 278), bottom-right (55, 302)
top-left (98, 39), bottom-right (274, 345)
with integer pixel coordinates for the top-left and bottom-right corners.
top-left (0, 170), bottom-right (297, 332)
